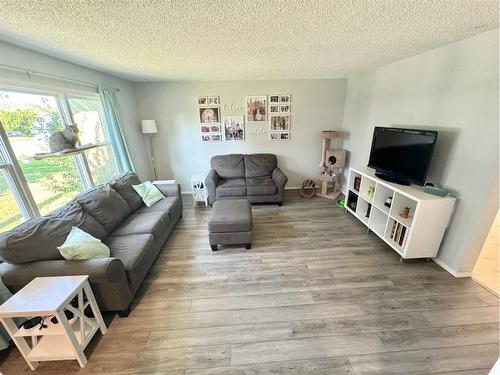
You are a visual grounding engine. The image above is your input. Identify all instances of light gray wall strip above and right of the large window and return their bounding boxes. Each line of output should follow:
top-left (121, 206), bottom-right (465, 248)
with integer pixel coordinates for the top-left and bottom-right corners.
top-left (0, 41), bottom-right (151, 179)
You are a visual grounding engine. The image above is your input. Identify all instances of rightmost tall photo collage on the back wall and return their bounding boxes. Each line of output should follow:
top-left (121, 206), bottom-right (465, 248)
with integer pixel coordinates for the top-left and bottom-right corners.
top-left (269, 94), bottom-right (292, 141)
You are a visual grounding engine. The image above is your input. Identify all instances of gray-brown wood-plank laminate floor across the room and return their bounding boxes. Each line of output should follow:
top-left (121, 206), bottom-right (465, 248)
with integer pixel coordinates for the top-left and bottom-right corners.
top-left (0, 191), bottom-right (498, 375)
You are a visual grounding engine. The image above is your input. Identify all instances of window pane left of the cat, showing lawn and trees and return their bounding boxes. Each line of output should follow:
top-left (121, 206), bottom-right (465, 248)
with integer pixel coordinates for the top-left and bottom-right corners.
top-left (0, 91), bottom-right (83, 215)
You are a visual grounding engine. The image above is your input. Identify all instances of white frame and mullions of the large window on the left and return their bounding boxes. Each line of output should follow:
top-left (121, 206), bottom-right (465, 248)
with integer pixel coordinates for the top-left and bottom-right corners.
top-left (0, 84), bottom-right (118, 226)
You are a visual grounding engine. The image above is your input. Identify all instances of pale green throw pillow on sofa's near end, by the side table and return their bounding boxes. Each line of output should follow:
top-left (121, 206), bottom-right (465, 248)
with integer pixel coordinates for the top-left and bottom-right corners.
top-left (57, 227), bottom-right (109, 260)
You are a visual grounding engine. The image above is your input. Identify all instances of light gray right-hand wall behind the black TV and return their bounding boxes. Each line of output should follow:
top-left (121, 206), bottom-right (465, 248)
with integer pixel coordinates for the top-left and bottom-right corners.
top-left (343, 30), bottom-right (499, 274)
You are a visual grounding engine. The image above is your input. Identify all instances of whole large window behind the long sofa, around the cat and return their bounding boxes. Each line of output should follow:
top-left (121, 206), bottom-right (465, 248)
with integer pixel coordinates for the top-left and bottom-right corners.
top-left (0, 89), bottom-right (125, 232)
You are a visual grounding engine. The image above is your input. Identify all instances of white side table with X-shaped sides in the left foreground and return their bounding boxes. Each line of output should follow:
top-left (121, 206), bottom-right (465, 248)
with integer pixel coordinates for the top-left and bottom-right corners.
top-left (0, 276), bottom-right (106, 370)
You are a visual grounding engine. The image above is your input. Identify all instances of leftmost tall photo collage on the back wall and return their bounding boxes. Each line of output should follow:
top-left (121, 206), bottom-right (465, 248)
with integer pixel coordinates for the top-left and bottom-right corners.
top-left (198, 96), bottom-right (222, 142)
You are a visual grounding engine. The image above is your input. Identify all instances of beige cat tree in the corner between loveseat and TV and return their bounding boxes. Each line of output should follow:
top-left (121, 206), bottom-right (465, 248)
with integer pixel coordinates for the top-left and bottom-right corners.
top-left (316, 130), bottom-right (346, 199)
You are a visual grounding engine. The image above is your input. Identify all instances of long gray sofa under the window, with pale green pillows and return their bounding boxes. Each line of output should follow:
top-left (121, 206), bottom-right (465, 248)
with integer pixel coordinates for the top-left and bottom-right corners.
top-left (0, 173), bottom-right (182, 316)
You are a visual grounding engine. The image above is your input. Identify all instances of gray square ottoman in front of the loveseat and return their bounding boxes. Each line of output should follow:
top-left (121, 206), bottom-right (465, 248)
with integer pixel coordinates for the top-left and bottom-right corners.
top-left (208, 199), bottom-right (252, 251)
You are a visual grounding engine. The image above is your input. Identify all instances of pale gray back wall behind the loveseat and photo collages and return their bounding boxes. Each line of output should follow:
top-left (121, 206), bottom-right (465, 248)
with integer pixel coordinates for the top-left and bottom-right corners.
top-left (137, 79), bottom-right (346, 191)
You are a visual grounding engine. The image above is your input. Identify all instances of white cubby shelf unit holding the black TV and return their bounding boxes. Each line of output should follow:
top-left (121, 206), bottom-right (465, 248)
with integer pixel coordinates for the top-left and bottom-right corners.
top-left (345, 168), bottom-right (455, 259)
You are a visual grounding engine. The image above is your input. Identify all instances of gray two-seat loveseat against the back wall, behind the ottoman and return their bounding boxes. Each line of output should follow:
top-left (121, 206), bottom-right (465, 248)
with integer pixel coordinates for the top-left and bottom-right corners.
top-left (205, 154), bottom-right (288, 206)
